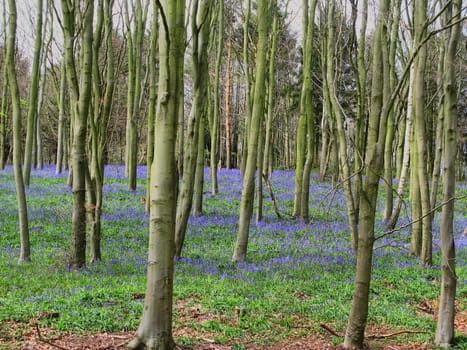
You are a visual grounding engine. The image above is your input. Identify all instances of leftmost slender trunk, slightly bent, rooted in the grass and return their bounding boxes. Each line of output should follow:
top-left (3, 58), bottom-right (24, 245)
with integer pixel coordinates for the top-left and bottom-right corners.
top-left (5, 0), bottom-right (31, 263)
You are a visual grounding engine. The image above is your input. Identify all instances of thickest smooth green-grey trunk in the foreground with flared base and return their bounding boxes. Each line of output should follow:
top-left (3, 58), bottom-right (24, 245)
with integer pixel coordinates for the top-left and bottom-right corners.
top-left (128, 0), bottom-right (185, 350)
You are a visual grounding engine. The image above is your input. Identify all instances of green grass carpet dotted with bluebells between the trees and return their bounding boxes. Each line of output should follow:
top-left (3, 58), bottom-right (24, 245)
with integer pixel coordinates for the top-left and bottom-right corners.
top-left (0, 166), bottom-right (467, 349)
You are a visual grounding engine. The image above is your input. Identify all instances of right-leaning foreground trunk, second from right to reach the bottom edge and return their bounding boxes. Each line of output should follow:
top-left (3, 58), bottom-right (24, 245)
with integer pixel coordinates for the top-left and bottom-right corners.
top-left (343, 0), bottom-right (390, 349)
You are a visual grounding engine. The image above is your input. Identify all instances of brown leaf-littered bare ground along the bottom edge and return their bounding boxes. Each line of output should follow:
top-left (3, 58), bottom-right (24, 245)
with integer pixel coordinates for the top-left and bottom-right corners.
top-left (4, 311), bottom-right (467, 350)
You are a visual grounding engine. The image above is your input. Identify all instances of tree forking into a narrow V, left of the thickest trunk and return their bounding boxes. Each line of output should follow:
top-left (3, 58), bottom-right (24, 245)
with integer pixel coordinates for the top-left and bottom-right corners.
top-left (61, 0), bottom-right (94, 269)
